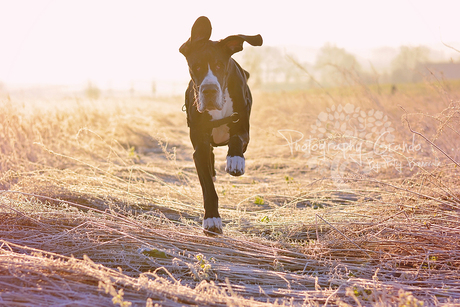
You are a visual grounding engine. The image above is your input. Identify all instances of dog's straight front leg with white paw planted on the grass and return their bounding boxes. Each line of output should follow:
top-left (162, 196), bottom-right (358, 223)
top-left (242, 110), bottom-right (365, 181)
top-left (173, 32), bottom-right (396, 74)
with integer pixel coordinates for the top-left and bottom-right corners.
top-left (193, 142), bottom-right (222, 235)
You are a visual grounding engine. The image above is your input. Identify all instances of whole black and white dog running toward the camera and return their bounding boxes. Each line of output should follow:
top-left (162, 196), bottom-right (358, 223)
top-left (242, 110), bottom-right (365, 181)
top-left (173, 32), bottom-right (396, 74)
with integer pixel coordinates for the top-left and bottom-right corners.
top-left (179, 16), bottom-right (262, 235)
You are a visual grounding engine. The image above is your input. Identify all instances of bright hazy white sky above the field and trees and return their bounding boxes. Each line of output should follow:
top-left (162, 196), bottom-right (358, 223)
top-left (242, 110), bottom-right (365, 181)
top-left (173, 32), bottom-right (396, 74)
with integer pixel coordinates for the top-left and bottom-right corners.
top-left (0, 0), bottom-right (460, 87)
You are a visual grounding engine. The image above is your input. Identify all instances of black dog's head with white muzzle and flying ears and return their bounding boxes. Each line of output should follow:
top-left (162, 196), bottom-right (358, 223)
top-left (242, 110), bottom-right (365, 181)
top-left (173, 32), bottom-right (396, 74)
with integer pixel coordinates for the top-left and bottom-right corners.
top-left (179, 16), bottom-right (262, 113)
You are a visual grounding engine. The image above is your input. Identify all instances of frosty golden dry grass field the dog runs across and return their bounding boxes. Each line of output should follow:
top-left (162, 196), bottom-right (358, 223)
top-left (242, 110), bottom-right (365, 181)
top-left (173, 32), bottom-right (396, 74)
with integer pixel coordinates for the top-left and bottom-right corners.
top-left (0, 78), bottom-right (460, 306)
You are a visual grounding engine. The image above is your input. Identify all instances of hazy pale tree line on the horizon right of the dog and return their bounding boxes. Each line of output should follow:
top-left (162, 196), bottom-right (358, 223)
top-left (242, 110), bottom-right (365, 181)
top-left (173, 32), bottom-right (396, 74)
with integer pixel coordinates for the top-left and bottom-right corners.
top-left (240, 44), bottom-right (456, 89)
